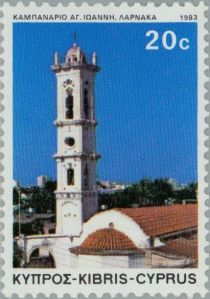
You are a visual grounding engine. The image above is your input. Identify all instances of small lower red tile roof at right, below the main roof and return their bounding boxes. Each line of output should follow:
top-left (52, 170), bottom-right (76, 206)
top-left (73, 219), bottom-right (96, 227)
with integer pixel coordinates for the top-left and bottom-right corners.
top-left (154, 238), bottom-right (198, 261)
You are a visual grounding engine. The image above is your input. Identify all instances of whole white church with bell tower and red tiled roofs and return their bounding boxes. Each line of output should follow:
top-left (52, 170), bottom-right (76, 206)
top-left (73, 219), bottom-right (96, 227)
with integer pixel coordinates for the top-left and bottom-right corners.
top-left (18, 44), bottom-right (198, 269)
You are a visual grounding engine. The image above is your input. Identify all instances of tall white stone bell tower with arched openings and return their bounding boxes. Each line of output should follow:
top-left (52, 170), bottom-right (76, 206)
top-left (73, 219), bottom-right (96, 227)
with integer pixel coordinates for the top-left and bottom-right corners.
top-left (51, 44), bottom-right (100, 236)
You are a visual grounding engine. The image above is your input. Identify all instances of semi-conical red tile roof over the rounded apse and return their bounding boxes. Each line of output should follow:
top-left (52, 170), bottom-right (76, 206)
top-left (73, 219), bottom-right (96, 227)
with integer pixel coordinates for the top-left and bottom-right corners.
top-left (70, 228), bottom-right (143, 255)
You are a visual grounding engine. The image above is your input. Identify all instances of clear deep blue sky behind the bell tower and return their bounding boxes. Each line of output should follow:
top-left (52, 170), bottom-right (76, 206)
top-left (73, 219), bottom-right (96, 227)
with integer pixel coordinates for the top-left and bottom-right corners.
top-left (13, 23), bottom-right (197, 185)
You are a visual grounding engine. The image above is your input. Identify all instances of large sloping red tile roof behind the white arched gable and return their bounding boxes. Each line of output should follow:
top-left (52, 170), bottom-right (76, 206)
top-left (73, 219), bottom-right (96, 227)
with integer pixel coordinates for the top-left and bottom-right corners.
top-left (115, 204), bottom-right (198, 237)
